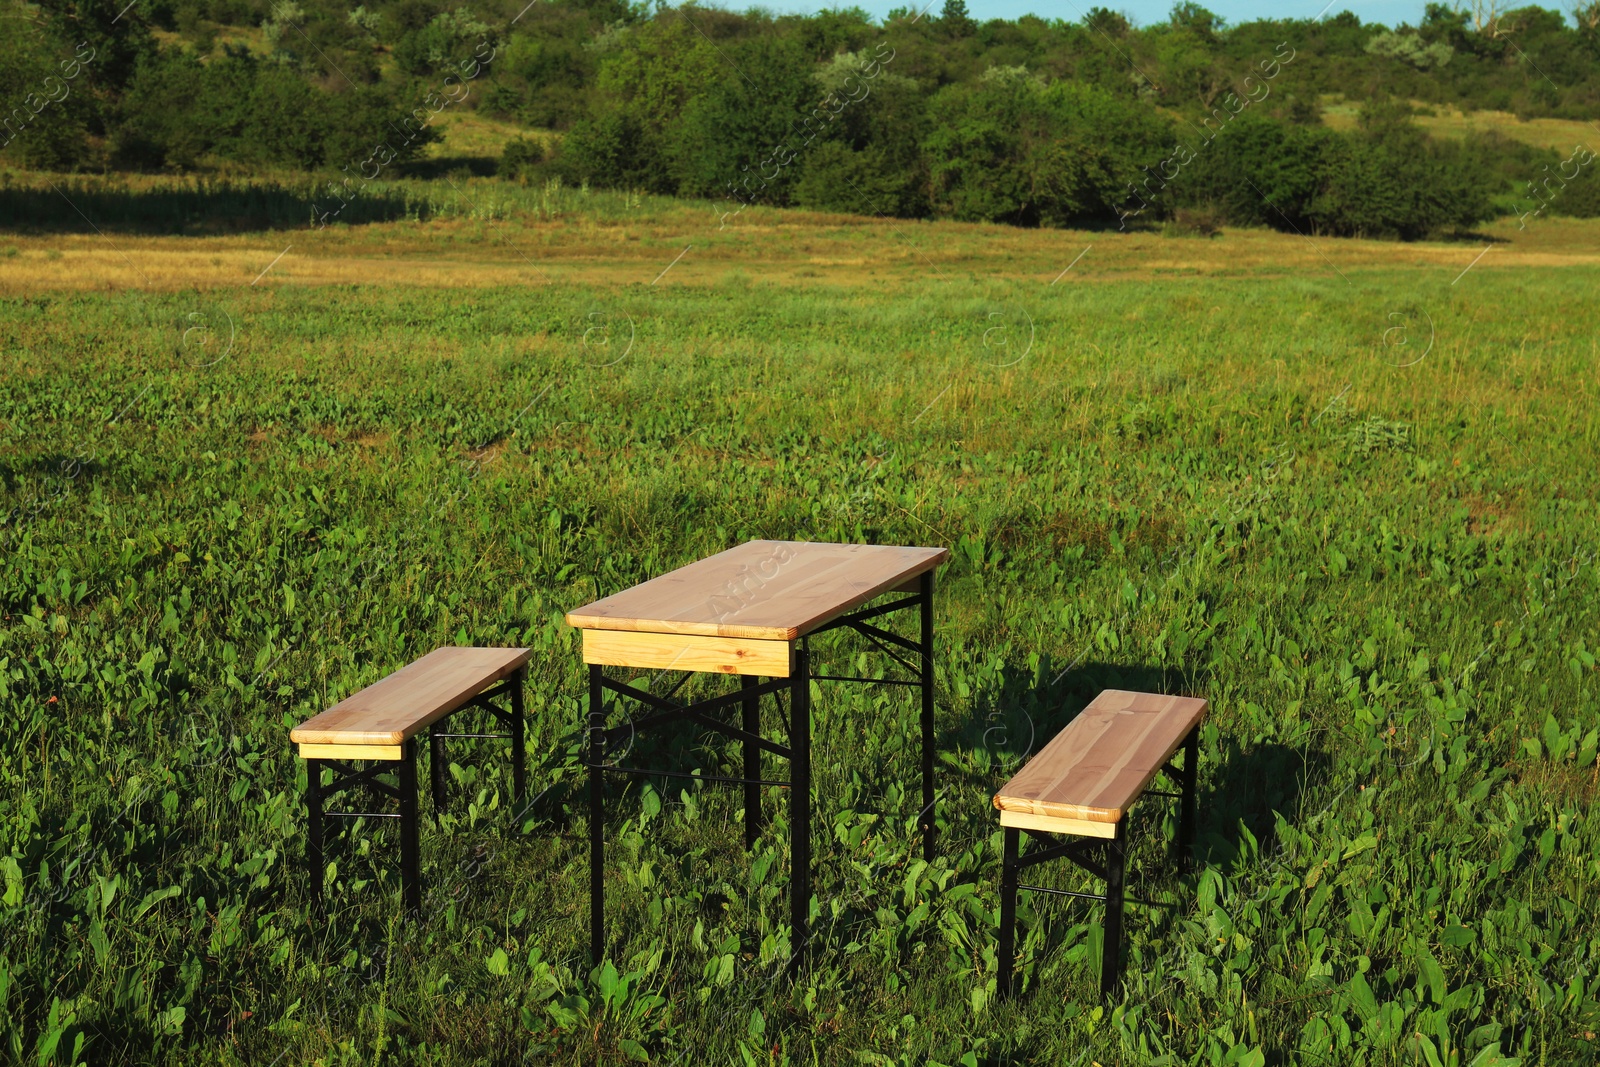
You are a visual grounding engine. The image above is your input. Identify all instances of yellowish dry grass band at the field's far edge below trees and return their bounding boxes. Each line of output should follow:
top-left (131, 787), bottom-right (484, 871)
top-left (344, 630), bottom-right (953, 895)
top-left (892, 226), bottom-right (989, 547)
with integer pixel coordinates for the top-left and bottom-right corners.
top-left (0, 210), bottom-right (1600, 296)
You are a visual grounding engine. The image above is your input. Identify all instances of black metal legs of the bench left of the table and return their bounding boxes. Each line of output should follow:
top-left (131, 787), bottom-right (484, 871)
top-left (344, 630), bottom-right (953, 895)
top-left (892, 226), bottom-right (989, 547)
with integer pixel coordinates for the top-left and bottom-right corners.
top-left (306, 664), bottom-right (528, 918)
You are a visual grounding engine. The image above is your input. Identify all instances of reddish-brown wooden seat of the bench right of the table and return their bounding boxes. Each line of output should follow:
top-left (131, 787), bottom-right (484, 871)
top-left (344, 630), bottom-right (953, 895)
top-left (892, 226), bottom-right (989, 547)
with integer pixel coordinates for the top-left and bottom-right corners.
top-left (995, 689), bottom-right (1206, 838)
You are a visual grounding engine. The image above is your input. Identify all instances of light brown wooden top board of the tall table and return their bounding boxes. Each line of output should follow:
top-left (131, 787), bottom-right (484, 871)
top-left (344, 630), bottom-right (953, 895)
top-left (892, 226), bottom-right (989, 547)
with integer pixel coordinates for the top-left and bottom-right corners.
top-left (566, 541), bottom-right (950, 641)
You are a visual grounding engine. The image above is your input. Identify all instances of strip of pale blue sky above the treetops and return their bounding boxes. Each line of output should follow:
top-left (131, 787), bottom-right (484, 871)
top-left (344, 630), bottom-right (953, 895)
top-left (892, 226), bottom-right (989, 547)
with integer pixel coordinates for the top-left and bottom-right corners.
top-left (761, 0), bottom-right (1440, 26)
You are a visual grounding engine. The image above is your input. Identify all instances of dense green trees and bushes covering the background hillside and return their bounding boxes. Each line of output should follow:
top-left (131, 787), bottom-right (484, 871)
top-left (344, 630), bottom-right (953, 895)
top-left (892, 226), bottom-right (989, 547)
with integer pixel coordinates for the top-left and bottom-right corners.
top-left (0, 0), bottom-right (1600, 238)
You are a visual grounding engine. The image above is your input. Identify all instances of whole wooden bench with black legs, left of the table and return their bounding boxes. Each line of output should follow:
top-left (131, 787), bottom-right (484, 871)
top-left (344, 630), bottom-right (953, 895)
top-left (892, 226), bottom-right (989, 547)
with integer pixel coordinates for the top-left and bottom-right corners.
top-left (290, 648), bottom-right (533, 913)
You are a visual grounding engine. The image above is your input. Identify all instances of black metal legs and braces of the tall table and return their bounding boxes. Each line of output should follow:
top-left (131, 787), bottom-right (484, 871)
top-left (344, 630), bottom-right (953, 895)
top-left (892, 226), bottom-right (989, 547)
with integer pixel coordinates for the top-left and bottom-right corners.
top-left (584, 571), bottom-right (936, 969)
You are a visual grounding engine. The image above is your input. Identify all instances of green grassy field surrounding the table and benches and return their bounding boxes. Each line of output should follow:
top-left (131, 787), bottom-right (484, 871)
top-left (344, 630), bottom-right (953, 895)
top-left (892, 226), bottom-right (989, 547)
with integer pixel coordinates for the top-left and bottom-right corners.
top-left (0, 182), bottom-right (1600, 1067)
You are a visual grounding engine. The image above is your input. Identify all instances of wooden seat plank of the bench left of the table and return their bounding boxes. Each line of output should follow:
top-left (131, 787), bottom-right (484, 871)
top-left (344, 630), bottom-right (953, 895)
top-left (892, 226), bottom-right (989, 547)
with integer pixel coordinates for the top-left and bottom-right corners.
top-left (290, 648), bottom-right (533, 745)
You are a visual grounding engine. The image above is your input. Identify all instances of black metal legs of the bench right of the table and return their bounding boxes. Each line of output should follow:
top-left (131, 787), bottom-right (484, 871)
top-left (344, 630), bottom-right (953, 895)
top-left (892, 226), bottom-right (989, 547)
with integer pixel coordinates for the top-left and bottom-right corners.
top-left (998, 723), bottom-right (1200, 997)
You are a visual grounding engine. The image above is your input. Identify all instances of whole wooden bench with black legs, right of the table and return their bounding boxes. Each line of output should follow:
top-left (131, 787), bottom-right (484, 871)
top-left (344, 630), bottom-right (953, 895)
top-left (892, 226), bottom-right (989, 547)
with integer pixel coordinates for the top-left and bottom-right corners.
top-left (995, 689), bottom-right (1206, 997)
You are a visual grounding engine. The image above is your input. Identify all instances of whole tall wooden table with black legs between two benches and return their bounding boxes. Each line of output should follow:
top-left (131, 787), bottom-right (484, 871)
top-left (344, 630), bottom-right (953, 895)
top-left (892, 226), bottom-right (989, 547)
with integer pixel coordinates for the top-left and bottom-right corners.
top-left (566, 541), bottom-right (950, 963)
